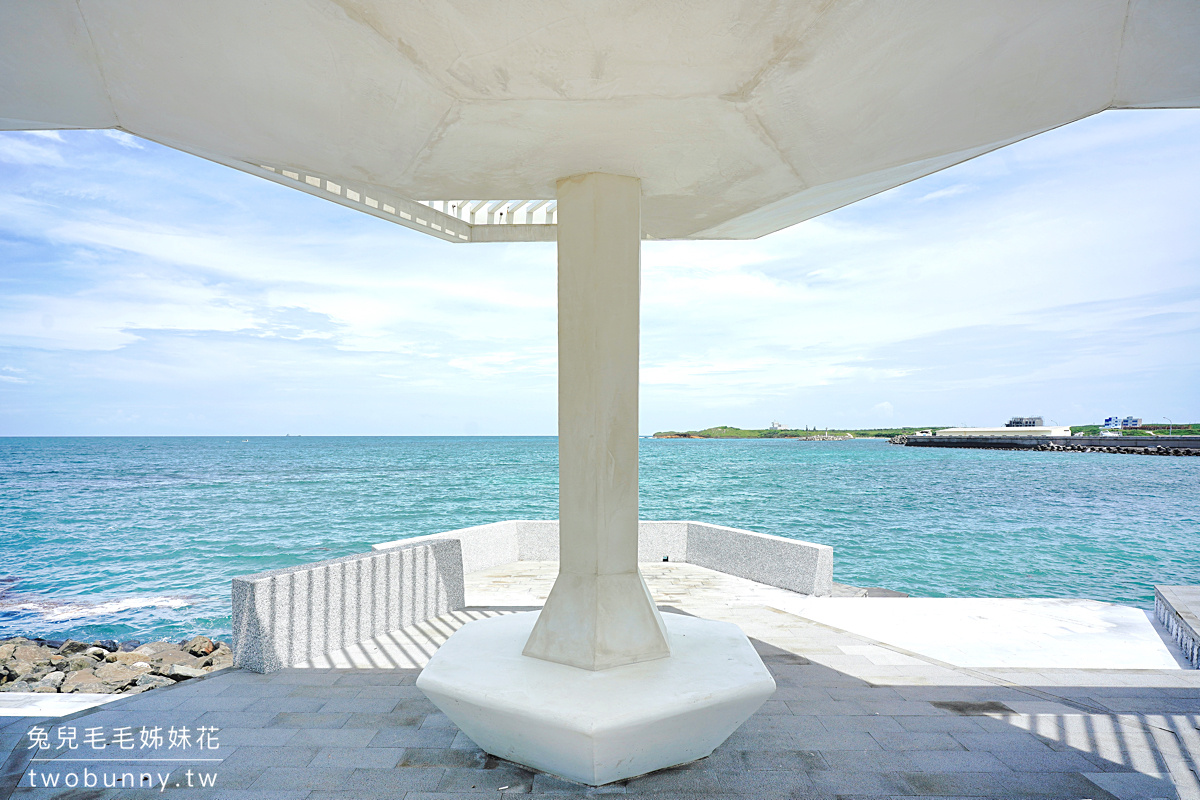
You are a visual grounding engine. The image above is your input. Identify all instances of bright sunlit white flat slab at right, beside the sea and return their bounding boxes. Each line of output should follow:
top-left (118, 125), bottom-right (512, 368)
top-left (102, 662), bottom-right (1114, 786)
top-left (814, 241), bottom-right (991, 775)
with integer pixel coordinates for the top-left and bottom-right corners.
top-left (778, 596), bottom-right (1180, 669)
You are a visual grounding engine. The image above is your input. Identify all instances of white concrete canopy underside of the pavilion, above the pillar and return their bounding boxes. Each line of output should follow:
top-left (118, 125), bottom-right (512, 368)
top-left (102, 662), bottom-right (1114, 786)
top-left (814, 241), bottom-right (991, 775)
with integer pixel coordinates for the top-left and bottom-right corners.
top-left (0, 0), bottom-right (1200, 239)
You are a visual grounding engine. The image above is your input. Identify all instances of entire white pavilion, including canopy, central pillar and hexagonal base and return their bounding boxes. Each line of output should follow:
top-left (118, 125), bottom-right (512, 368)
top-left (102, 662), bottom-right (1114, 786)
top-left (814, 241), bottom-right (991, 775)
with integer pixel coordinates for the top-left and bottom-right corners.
top-left (0, 0), bottom-right (1200, 783)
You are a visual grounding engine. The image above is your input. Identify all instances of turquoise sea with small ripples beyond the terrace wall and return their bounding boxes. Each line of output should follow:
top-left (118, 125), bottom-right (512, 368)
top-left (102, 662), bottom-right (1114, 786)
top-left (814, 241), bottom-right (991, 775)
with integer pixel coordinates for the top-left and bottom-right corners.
top-left (0, 437), bottom-right (1200, 640)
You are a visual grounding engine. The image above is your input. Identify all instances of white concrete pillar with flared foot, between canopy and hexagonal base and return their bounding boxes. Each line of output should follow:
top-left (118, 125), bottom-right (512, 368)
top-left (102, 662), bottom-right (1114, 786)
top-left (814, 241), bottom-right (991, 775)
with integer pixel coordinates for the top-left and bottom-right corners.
top-left (524, 173), bottom-right (671, 669)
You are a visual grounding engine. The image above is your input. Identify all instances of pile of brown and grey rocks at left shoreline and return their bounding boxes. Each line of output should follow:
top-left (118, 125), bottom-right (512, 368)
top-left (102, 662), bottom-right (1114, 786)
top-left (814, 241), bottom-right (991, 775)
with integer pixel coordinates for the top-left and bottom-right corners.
top-left (0, 636), bottom-right (233, 694)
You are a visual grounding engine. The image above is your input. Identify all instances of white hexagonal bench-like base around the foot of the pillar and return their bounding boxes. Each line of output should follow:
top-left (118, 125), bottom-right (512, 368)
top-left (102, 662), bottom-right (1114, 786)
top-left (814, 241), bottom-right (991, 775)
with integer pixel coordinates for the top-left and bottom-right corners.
top-left (416, 612), bottom-right (775, 786)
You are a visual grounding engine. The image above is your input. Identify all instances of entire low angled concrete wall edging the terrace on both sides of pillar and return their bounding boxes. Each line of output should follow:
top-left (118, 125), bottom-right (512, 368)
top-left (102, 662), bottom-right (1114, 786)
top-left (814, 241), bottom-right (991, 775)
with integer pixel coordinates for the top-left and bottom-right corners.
top-left (233, 519), bottom-right (833, 673)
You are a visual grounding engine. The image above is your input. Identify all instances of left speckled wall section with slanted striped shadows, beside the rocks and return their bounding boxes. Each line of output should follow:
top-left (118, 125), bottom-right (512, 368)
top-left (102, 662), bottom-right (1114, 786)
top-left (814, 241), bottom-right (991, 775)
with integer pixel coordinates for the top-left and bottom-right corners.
top-left (233, 537), bottom-right (466, 673)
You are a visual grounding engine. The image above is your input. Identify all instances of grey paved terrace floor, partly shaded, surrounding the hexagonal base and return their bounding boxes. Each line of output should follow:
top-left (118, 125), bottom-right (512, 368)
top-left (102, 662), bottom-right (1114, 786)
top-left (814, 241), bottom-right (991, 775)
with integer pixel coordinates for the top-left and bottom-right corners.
top-left (0, 564), bottom-right (1200, 800)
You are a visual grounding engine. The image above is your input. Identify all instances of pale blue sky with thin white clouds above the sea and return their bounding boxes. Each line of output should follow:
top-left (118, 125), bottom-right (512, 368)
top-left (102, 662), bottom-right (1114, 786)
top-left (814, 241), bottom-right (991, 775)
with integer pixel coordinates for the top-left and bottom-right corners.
top-left (0, 110), bottom-right (1200, 435)
